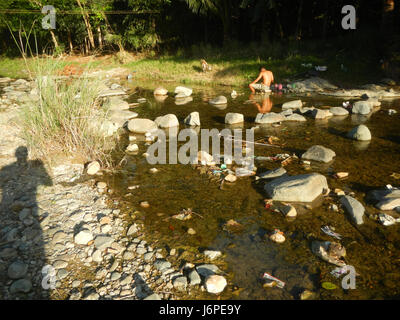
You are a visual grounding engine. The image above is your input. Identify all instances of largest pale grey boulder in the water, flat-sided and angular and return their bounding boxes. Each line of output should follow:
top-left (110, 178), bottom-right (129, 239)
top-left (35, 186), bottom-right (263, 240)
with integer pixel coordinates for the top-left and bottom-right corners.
top-left (264, 173), bottom-right (328, 202)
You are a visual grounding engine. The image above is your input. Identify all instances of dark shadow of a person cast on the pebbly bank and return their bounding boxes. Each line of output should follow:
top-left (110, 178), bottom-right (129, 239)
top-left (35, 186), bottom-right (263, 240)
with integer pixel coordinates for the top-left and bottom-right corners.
top-left (0, 146), bottom-right (53, 300)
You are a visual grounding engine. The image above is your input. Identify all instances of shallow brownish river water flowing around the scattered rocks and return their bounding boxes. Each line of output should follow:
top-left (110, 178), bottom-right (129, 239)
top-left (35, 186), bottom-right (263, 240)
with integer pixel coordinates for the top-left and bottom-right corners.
top-left (104, 83), bottom-right (400, 299)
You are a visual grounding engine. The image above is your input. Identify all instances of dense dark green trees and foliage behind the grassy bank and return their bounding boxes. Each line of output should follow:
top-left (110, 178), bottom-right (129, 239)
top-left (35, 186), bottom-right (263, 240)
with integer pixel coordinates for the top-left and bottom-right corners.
top-left (0, 0), bottom-right (400, 62)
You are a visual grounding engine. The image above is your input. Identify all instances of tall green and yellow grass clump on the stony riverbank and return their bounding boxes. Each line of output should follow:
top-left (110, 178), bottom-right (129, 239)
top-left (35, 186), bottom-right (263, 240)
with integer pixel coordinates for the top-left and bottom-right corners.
top-left (21, 58), bottom-right (113, 165)
